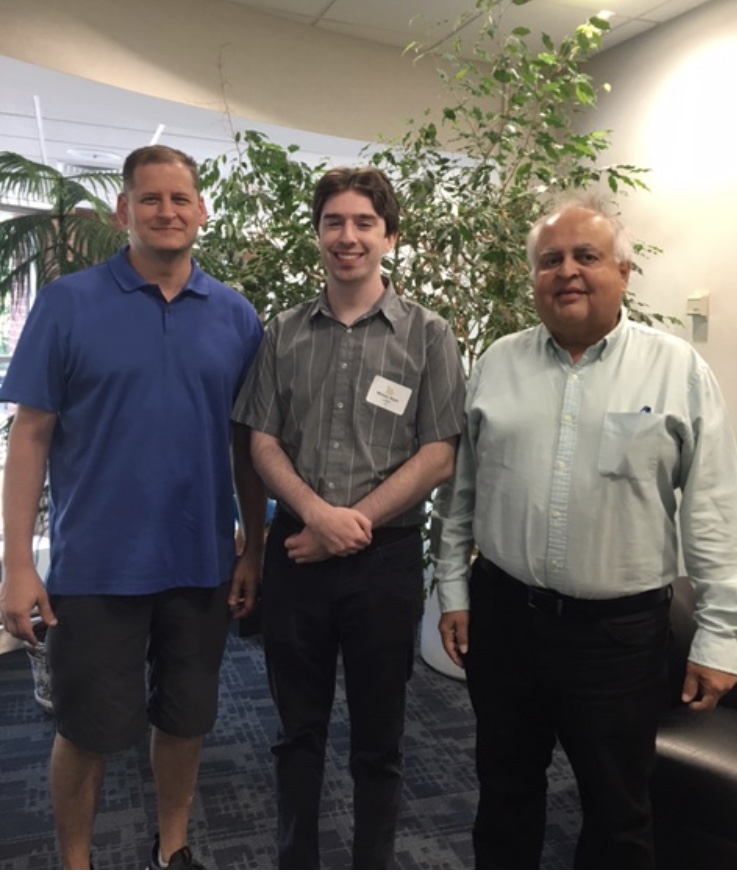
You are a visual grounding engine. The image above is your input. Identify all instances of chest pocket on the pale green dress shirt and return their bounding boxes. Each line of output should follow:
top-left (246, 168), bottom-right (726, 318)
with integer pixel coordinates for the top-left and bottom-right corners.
top-left (599, 412), bottom-right (665, 481)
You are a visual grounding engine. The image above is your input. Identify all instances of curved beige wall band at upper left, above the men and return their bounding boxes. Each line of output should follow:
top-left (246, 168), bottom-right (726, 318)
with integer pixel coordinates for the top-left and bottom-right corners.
top-left (0, 0), bottom-right (439, 141)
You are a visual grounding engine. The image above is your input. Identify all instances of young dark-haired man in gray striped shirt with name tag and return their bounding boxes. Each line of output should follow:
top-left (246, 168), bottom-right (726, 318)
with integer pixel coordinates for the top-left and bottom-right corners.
top-left (234, 167), bottom-right (464, 869)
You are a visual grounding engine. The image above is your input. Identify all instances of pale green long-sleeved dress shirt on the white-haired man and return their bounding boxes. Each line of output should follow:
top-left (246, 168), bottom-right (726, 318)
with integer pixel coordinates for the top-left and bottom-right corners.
top-left (436, 310), bottom-right (737, 672)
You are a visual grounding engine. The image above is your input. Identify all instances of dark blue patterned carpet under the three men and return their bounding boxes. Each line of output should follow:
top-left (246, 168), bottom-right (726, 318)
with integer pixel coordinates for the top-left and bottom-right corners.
top-left (0, 635), bottom-right (579, 869)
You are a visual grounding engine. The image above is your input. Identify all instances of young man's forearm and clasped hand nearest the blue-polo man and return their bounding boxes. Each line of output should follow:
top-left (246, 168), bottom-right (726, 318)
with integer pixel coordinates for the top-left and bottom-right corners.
top-left (251, 430), bottom-right (371, 562)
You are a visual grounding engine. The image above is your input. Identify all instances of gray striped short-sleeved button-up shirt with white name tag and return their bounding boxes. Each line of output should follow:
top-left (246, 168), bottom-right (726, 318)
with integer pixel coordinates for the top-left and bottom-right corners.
top-left (233, 285), bottom-right (465, 526)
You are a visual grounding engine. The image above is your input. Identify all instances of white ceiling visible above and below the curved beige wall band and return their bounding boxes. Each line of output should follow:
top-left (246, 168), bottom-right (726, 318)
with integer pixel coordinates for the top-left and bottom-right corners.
top-left (0, 0), bottom-right (707, 175)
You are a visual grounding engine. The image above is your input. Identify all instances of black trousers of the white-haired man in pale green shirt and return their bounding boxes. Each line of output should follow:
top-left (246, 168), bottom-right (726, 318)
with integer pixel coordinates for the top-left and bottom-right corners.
top-left (466, 560), bottom-right (669, 869)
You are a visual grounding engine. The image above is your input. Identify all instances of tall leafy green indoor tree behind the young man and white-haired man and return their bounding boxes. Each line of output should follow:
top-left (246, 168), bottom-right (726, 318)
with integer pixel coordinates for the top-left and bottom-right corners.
top-left (193, 0), bottom-right (664, 674)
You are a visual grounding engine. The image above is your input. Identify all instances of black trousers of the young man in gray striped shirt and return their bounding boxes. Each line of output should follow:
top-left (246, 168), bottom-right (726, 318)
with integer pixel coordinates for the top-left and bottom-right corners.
top-left (262, 516), bottom-right (423, 869)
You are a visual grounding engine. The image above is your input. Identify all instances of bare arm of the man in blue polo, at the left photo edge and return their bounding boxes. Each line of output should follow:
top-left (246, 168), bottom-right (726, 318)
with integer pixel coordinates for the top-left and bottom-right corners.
top-left (0, 406), bottom-right (57, 645)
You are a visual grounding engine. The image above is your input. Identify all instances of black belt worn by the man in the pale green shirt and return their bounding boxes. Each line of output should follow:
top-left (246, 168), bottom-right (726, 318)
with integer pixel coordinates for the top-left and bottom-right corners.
top-left (477, 555), bottom-right (672, 621)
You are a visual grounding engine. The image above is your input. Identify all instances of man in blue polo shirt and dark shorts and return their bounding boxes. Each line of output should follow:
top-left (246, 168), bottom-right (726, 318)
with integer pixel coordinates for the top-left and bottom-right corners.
top-left (0, 146), bottom-right (265, 869)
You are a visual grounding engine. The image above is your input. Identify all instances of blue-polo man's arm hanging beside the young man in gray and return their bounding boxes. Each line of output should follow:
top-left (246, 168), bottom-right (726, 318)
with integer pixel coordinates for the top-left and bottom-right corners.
top-left (228, 423), bottom-right (266, 618)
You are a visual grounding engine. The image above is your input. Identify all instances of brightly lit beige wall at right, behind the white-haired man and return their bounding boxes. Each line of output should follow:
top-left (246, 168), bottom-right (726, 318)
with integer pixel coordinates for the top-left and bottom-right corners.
top-left (590, 0), bottom-right (737, 429)
